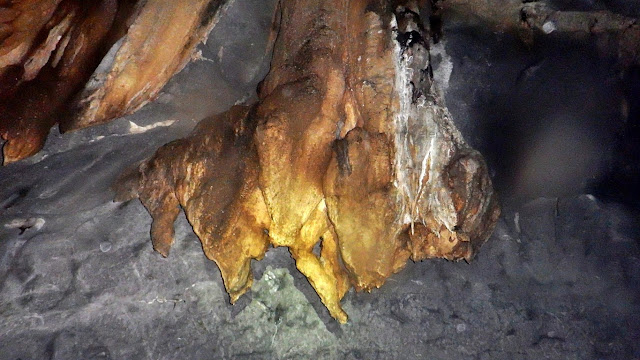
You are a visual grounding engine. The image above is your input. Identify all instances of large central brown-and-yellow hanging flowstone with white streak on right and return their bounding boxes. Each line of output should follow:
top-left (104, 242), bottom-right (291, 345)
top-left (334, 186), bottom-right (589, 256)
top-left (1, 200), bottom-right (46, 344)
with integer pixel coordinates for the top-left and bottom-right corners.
top-left (116, 0), bottom-right (499, 322)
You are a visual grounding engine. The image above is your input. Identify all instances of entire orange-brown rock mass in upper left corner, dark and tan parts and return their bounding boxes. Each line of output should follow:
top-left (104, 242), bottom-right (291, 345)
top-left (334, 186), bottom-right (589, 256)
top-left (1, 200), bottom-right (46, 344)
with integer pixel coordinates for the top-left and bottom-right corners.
top-left (0, 0), bottom-right (225, 164)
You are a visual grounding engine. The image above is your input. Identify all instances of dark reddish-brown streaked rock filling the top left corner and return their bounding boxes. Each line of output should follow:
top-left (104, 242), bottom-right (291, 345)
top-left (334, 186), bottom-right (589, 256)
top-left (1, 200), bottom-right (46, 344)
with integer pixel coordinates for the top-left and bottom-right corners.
top-left (0, 0), bottom-right (117, 164)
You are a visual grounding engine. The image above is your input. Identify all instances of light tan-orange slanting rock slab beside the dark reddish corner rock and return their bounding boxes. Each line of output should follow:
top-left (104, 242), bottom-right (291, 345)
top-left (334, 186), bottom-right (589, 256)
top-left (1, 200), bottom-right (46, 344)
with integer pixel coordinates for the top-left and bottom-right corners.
top-left (61, 0), bottom-right (230, 131)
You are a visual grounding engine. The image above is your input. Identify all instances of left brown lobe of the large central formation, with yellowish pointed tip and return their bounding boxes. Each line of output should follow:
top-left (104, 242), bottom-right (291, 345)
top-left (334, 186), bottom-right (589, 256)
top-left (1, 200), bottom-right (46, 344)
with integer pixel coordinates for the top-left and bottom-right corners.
top-left (116, 106), bottom-right (271, 302)
